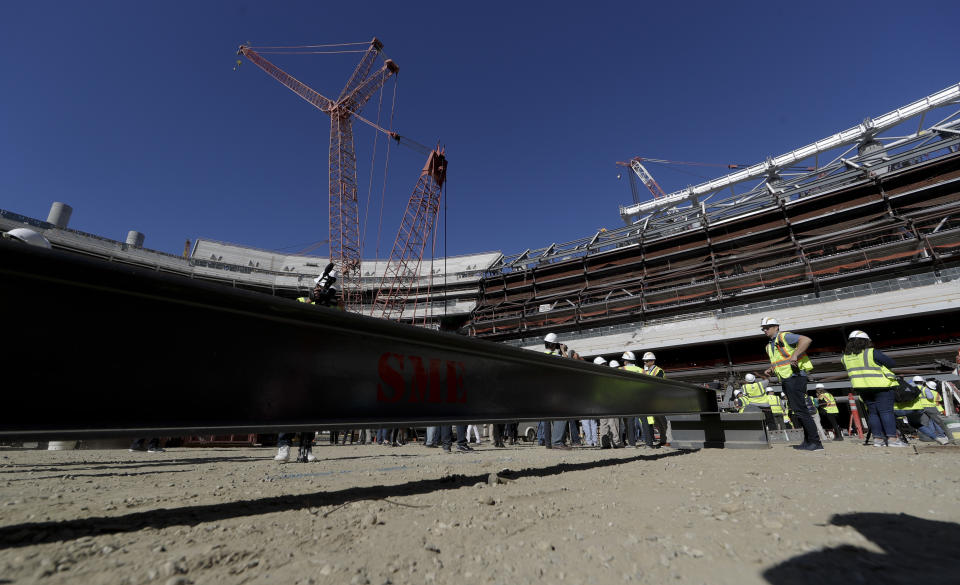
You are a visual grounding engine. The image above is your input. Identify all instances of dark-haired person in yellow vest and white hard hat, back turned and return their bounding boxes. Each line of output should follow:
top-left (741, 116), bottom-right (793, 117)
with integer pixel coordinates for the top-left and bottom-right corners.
top-left (841, 329), bottom-right (907, 447)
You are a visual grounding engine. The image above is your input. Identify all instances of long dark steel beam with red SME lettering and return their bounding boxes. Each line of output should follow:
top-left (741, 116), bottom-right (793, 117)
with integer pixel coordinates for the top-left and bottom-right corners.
top-left (0, 241), bottom-right (716, 439)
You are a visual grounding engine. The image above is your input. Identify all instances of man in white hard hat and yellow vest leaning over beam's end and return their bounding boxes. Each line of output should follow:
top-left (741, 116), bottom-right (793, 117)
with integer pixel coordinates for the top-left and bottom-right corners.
top-left (760, 317), bottom-right (823, 451)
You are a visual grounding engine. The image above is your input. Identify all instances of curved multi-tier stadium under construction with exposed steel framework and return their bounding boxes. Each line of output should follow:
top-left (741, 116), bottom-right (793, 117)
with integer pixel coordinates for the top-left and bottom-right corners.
top-left (0, 84), bottom-right (960, 390)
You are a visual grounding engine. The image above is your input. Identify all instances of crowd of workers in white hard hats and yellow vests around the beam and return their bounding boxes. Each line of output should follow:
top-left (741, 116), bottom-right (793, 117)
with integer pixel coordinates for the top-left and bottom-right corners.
top-left (276, 317), bottom-right (952, 461)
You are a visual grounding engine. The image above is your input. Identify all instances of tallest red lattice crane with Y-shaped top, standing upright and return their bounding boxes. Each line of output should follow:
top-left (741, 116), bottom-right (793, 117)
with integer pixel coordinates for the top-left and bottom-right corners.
top-left (237, 39), bottom-right (399, 312)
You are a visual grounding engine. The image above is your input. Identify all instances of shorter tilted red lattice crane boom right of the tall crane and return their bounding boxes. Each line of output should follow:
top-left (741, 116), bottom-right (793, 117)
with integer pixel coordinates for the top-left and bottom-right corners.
top-left (370, 148), bottom-right (447, 322)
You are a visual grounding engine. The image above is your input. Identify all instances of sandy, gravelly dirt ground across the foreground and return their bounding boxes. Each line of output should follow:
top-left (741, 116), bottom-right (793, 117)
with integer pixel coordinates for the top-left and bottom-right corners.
top-left (0, 440), bottom-right (960, 585)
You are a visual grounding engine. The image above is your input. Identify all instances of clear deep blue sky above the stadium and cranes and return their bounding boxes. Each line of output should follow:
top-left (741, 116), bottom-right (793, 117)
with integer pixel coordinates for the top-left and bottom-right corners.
top-left (0, 0), bottom-right (960, 258)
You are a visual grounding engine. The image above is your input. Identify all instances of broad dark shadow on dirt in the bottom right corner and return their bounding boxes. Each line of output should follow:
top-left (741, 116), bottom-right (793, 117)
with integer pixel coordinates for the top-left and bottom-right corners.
top-left (763, 513), bottom-right (960, 585)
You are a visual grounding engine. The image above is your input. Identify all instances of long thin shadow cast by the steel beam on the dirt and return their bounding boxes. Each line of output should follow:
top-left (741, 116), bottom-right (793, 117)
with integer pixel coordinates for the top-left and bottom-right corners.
top-left (0, 451), bottom-right (693, 549)
